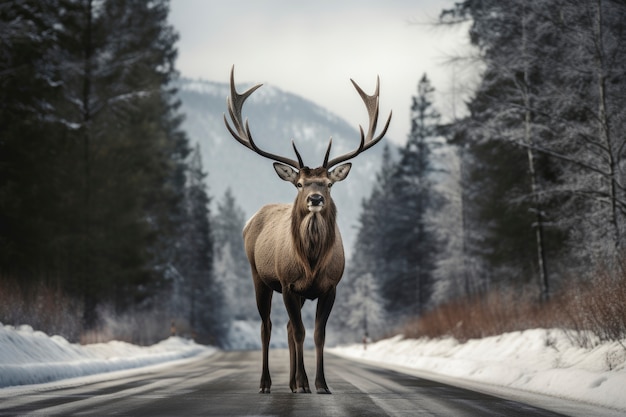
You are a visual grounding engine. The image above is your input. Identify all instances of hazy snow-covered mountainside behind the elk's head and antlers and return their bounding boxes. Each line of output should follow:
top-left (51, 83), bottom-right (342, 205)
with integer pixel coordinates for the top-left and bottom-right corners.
top-left (173, 79), bottom-right (388, 254)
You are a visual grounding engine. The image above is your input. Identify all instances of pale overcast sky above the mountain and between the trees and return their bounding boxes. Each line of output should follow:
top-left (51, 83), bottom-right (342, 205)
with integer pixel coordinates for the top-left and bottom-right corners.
top-left (170, 0), bottom-right (467, 143)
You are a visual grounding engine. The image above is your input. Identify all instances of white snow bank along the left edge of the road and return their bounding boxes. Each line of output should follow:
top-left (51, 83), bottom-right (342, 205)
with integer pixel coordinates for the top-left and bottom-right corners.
top-left (0, 323), bottom-right (216, 388)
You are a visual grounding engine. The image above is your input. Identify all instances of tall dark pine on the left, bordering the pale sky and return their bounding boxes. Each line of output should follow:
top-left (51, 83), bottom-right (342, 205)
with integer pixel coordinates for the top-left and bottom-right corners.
top-left (60, 0), bottom-right (188, 325)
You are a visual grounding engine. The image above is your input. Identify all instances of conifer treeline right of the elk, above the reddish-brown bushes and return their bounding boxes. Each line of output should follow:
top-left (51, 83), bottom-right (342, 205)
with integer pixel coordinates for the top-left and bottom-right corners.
top-left (336, 0), bottom-right (626, 338)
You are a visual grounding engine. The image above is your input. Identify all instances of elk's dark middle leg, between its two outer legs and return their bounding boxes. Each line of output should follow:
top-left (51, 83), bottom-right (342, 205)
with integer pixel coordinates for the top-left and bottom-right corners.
top-left (283, 289), bottom-right (311, 392)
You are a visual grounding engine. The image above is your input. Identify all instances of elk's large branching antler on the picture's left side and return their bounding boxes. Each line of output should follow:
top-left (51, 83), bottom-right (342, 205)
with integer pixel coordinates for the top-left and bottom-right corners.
top-left (224, 65), bottom-right (304, 169)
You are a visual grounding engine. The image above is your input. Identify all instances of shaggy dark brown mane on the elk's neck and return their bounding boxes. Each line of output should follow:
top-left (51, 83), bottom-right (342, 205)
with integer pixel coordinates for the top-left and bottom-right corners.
top-left (291, 200), bottom-right (337, 279)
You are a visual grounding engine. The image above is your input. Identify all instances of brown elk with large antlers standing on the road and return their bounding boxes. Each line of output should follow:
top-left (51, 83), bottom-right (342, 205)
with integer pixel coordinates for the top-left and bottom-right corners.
top-left (224, 66), bottom-right (391, 394)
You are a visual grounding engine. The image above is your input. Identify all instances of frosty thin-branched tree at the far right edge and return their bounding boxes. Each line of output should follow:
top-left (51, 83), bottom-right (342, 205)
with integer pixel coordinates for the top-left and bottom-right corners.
top-left (536, 0), bottom-right (626, 259)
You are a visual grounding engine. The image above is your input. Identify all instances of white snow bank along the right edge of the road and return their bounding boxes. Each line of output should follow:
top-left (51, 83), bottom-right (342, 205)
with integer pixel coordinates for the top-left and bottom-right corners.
top-left (328, 329), bottom-right (626, 411)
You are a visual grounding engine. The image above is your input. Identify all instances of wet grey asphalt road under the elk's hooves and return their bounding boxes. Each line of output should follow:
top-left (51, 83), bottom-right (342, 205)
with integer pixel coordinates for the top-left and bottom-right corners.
top-left (0, 350), bottom-right (600, 417)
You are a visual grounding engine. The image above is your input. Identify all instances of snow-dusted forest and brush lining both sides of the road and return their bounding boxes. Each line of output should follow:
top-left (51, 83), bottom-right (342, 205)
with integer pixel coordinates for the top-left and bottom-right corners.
top-left (0, 0), bottom-right (626, 346)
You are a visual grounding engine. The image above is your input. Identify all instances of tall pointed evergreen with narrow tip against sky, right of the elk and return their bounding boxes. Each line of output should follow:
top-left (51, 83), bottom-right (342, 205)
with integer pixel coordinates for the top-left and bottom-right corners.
top-left (384, 74), bottom-right (440, 317)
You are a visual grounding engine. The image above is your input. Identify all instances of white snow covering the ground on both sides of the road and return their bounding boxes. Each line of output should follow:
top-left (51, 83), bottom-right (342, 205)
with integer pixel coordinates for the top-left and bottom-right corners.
top-left (0, 323), bottom-right (626, 415)
